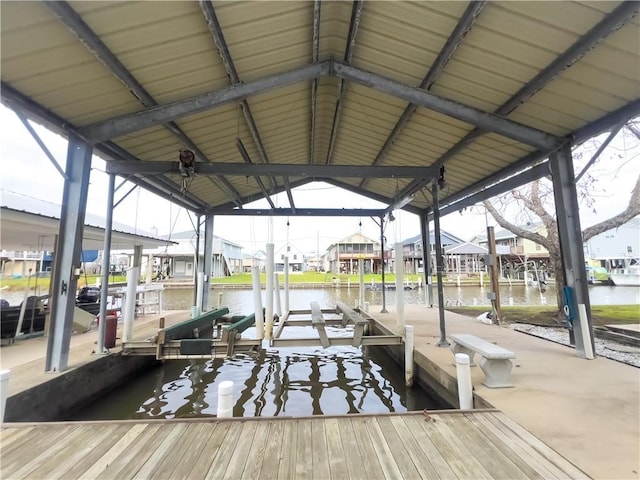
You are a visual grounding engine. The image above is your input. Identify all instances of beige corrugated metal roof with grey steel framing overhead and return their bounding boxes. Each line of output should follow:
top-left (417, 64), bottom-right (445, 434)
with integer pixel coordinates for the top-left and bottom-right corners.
top-left (0, 0), bottom-right (640, 218)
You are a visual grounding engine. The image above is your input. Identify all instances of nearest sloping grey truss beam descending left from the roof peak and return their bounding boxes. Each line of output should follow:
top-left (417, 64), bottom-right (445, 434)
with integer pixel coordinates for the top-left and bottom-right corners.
top-left (80, 60), bottom-right (331, 142)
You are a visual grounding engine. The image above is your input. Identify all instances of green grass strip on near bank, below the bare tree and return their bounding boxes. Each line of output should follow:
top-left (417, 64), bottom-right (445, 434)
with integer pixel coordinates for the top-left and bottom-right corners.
top-left (447, 305), bottom-right (640, 326)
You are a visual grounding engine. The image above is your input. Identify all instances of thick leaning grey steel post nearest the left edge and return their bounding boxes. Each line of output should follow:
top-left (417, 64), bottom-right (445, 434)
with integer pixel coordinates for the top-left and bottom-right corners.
top-left (45, 135), bottom-right (92, 372)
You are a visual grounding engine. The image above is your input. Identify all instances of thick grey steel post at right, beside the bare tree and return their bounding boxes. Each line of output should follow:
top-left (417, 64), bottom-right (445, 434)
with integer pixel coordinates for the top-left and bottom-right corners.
top-left (550, 145), bottom-right (595, 358)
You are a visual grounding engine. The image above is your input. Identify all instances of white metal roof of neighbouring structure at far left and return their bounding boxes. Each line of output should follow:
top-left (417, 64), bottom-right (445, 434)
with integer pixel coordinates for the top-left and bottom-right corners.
top-left (0, 191), bottom-right (176, 252)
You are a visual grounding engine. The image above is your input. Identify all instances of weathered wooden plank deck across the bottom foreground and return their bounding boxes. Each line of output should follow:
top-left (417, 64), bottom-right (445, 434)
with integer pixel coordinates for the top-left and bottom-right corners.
top-left (0, 411), bottom-right (586, 480)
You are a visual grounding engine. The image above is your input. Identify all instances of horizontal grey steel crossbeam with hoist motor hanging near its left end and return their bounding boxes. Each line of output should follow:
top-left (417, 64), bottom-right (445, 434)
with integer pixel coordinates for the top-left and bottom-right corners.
top-left (106, 161), bottom-right (438, 178)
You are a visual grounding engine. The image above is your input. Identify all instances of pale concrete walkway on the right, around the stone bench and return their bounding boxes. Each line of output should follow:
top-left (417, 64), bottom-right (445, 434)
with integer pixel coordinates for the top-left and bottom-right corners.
top-left (369, 305), bottom-right (640, 479)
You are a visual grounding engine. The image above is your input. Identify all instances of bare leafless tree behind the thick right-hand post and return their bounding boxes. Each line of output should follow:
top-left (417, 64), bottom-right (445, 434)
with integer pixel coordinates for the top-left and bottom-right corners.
top-left (484, 119), bottom-right (640, 310)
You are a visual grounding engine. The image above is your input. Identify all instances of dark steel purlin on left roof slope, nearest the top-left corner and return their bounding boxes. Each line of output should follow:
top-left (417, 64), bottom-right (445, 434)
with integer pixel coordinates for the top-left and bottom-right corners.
top-left (44, 0), bottom-right (240, 209)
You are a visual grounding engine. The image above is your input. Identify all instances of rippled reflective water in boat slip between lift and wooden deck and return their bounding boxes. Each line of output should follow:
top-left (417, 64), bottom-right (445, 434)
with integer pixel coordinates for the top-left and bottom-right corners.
top-left (128, 347), bottom-right (439, 418)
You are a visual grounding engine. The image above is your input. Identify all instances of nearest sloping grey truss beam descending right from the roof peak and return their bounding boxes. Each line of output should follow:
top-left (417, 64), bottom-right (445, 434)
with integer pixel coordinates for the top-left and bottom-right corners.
top-left (333, 62), bottom-right (564, 150)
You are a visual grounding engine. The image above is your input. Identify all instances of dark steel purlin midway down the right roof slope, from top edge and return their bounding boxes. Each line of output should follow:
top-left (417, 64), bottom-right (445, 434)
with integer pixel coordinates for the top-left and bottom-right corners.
top-left (360, 0), bottom-right (487, 187)
